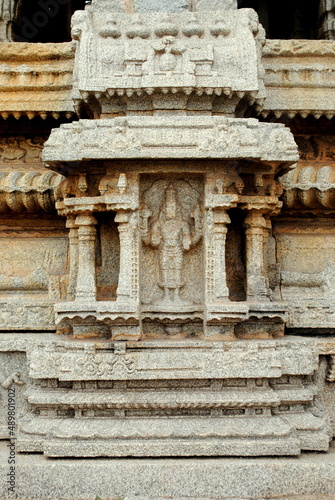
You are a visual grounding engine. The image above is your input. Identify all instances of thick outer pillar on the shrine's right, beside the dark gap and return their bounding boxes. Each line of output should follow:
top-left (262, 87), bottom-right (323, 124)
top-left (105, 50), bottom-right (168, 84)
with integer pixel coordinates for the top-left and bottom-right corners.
top-left (244, 209), bottom-right (269, 301)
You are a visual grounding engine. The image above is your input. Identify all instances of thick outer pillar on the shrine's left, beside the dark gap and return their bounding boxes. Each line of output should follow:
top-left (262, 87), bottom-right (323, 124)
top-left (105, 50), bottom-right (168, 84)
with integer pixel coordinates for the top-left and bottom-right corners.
top-left (75, 215), bottom-right (98, 301)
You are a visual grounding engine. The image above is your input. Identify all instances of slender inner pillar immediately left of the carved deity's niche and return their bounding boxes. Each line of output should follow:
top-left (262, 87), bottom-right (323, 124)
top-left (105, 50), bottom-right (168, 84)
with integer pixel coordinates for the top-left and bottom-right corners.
top-left (115, 210), bottom-right (139, 303)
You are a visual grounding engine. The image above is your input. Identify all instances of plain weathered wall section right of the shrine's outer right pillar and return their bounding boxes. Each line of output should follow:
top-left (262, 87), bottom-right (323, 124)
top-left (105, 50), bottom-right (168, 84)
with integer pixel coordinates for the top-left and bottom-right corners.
top-left (275, 220), bottom-right (334, 331)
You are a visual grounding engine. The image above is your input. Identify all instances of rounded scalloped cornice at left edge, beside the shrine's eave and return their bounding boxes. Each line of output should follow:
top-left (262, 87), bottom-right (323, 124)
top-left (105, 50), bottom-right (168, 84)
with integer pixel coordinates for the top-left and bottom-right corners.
top-left (0, 171), bottom-right (63, 213)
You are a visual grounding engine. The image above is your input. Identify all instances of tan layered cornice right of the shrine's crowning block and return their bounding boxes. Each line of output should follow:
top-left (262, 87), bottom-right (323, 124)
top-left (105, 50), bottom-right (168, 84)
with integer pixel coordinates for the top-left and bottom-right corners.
top-left (262, 40), bottom-right (335, 119)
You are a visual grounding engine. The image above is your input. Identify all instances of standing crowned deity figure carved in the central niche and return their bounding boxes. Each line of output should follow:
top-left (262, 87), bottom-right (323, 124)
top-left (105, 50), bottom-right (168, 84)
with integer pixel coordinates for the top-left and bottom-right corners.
top-left (142, 183), bottom-right (202, 304)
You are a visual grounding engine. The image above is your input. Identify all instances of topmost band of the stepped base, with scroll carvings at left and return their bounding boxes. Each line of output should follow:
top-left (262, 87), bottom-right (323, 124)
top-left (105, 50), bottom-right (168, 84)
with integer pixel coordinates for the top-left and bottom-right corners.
top-left (29, 339), bottom-right (318, 381)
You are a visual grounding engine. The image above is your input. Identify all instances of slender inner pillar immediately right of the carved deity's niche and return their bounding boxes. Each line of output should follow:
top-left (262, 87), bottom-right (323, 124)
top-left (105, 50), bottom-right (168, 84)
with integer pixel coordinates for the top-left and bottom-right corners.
top-left (211, 210), bottom-right (230, 300)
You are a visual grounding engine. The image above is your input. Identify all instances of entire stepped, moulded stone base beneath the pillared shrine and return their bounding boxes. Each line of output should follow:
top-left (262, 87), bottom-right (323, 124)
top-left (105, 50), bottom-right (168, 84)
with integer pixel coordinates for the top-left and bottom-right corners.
top-left (10, 339), bottom-right (331, 457)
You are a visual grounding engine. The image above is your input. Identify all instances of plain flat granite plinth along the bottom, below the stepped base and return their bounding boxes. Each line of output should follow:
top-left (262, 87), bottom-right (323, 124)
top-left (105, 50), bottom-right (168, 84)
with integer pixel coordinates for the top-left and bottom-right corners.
top-left (0, 442), bottom-right (335, 500)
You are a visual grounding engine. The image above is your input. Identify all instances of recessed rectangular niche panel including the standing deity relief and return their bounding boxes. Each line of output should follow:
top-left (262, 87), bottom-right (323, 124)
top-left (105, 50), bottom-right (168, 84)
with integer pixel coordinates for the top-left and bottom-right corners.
top-left (140, 177), bottom-right (203, 310)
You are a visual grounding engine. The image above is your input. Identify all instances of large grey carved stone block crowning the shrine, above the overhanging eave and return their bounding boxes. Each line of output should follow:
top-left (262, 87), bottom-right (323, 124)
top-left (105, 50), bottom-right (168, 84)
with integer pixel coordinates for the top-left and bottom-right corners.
top-left (72, 9), bottom-right (265, 116)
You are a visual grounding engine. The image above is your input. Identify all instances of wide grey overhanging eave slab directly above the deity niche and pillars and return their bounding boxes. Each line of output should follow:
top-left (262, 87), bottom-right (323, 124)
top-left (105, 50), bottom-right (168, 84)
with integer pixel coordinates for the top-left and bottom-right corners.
top-left (43, 116), bottom-right (298, 165)
